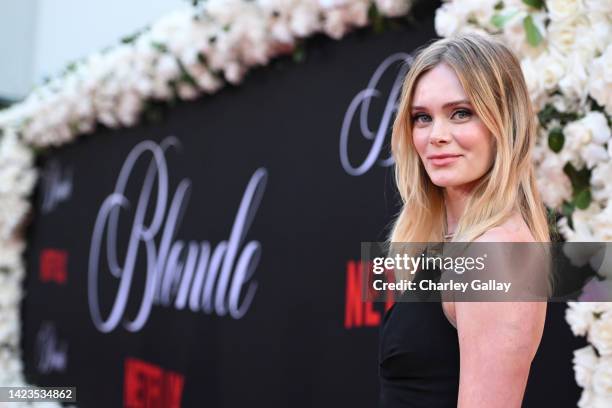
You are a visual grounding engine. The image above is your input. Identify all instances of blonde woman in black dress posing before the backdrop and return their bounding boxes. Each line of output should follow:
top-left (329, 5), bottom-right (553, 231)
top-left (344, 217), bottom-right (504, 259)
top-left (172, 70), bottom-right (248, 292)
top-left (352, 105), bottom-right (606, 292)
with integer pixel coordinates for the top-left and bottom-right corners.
top-left (379, 34), bottom-right (550, 408)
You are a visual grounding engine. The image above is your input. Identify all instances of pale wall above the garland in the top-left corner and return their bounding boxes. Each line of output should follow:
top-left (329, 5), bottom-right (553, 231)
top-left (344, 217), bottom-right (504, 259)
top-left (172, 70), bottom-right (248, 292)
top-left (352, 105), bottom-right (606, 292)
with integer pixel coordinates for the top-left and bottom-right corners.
top-left (0, 0), bottom-right (186, 98)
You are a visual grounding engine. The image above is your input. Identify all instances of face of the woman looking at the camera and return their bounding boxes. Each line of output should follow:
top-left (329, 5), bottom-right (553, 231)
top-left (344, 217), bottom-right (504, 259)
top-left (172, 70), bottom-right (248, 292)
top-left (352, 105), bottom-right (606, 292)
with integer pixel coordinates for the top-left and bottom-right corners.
top-left (411, 63), bottom-right (495, 188)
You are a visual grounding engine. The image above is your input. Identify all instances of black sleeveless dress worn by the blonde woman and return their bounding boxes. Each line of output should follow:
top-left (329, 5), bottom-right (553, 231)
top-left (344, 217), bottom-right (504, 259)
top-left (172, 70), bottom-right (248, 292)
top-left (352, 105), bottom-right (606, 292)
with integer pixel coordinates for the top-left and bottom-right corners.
top-left (378, 260), bottom-right (459, 408)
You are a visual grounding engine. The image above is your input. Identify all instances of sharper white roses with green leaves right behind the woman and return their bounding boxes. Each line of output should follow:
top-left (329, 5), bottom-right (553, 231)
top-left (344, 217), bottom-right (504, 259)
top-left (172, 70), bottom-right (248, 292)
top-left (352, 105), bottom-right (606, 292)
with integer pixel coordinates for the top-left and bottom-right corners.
top-left (436, 0), bottom-right (612, 408)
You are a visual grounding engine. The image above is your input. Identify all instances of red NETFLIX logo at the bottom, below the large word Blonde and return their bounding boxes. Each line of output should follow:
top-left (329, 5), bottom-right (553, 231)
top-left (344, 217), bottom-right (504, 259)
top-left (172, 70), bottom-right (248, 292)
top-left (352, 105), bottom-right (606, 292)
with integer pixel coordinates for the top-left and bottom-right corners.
top-left (123, 358), bottom-right (185, 408)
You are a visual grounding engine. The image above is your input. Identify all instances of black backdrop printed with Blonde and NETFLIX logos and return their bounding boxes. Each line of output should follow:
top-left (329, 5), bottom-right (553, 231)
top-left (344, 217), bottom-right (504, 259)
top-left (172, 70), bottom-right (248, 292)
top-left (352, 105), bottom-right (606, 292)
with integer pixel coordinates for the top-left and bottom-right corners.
top-left (23, 6), bottom-right (583, 407)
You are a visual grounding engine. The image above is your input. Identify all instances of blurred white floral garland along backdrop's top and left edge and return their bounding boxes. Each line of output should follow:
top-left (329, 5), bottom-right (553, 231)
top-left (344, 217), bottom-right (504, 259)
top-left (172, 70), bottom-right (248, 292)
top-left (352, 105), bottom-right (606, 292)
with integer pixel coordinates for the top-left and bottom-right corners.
top-left (0, 0), bottom-right (412, 406)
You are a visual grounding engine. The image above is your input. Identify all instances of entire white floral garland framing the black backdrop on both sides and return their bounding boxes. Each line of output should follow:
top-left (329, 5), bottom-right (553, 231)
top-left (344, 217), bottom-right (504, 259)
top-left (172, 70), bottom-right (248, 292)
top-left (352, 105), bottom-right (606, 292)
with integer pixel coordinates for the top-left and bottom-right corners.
top-left (0, 0), bottom-right (612, 407)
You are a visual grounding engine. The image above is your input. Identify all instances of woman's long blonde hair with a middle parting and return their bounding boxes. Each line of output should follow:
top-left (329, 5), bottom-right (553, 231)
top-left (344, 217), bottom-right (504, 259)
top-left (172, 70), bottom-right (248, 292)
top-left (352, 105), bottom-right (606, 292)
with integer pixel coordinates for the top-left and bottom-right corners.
top-left (390, 34), bottom-right (550, 242)
